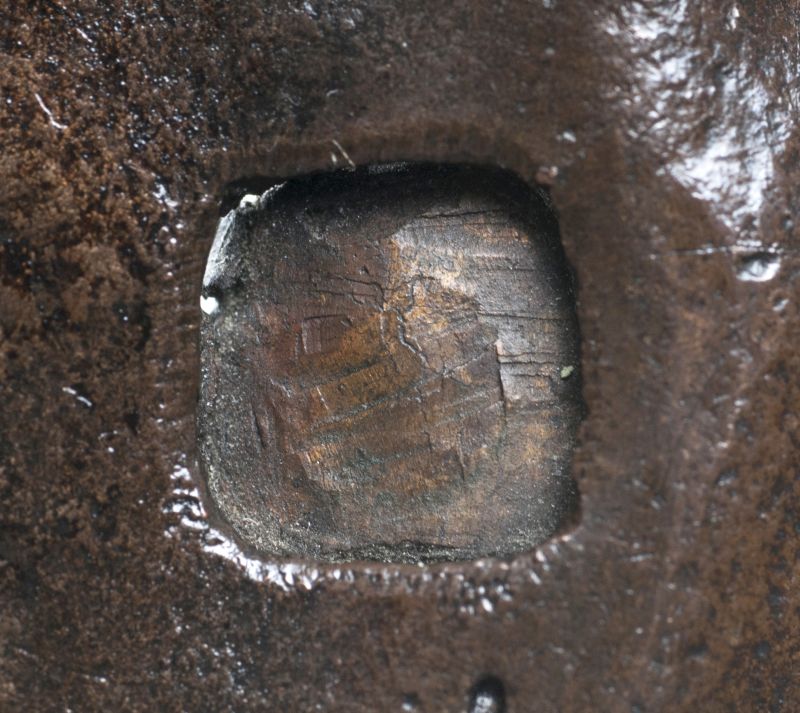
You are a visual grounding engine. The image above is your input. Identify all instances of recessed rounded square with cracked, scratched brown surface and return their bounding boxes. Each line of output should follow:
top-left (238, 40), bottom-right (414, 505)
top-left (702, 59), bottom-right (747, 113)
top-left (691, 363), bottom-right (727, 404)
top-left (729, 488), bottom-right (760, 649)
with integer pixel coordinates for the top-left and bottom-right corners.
top-left (198, 166), bottom-right (581, 561)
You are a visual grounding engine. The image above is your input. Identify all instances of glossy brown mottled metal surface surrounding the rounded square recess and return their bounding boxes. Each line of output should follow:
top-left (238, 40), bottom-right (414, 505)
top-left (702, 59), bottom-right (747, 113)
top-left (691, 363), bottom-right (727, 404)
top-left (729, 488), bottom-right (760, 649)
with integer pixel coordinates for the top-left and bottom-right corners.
top-left (0, 0), bottom-right (800, 712)
